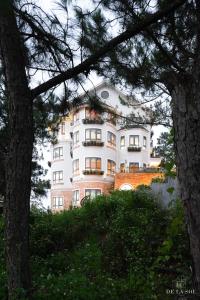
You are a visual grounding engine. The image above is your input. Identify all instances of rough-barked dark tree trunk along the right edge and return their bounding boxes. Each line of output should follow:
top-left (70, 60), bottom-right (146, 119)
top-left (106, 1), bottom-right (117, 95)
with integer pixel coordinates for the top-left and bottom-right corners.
top-left (172, 76), bottom-right (200, 291)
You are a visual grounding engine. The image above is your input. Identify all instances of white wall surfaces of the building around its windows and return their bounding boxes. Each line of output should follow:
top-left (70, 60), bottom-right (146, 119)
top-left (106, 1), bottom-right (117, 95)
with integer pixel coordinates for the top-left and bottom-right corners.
top-left (51, 86), bottom-right (151, 207)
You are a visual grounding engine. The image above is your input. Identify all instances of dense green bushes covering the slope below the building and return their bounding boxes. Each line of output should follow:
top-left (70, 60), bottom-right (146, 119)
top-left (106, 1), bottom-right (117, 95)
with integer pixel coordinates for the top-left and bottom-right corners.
top-left (0, 191), bottom-right (190, 300)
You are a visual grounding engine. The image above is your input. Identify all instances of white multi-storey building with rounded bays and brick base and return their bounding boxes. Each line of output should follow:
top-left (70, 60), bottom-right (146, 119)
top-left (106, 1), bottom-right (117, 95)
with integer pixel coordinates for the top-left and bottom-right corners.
top-left (51, 82), bottom-right (159, 210)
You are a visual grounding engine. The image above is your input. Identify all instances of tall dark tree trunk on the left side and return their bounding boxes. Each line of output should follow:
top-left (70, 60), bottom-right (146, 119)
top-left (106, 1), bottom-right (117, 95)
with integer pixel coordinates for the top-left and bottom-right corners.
top-left (0, 0), bottom-right (33, 299)
